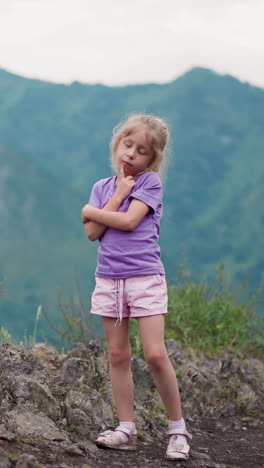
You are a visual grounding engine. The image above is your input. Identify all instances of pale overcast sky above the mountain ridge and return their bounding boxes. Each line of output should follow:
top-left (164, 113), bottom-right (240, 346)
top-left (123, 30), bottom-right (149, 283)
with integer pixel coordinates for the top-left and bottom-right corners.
top-left (0, 0), bottom-right (264, 87)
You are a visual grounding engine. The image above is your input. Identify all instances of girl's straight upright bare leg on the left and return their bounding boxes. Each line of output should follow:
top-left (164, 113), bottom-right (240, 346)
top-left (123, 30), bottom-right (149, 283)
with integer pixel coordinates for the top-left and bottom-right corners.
top-left (103, 317), bottom-right (134, 421)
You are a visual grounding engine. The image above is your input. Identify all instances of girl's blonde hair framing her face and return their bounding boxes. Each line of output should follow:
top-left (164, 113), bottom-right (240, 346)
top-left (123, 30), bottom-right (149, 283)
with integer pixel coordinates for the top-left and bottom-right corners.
top-left (110, 114), bottom-right (169, 172)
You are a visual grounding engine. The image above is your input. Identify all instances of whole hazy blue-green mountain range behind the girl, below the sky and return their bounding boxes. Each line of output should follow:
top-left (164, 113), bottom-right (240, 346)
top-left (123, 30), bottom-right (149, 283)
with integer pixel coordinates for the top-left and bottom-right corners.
top-left (0, 68), bottom-right (264, 336)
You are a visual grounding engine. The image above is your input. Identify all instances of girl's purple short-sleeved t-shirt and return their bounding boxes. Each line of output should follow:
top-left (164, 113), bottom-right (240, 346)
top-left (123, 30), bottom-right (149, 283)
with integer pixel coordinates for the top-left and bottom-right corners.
top-left (89, 172), bottom-right (165, 279)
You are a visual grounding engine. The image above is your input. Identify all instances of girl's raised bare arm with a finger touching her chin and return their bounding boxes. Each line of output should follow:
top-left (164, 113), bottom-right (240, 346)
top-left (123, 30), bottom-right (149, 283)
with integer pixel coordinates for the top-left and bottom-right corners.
top-left (82, 166), bottom-right (135, 241)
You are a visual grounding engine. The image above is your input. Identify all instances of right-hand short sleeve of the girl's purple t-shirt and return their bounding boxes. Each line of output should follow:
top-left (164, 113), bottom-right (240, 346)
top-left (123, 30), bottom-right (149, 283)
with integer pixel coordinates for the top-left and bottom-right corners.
top-left (129, 172), bottom-right (162, 212)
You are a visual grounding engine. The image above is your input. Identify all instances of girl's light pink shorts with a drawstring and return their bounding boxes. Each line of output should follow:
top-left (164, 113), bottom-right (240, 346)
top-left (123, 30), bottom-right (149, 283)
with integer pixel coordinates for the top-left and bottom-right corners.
top-left (91, 275), bottom-right (168, 323)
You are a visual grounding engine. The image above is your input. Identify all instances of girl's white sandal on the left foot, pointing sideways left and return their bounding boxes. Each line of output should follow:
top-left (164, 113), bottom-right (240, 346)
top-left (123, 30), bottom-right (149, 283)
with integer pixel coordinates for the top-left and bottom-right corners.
top-left (95, 426), bottom-right (137, 450)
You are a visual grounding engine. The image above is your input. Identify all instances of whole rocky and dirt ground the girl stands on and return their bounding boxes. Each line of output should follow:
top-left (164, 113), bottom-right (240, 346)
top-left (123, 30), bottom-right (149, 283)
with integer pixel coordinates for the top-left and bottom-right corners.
top-left (0, 340), bottom-right (264, 468)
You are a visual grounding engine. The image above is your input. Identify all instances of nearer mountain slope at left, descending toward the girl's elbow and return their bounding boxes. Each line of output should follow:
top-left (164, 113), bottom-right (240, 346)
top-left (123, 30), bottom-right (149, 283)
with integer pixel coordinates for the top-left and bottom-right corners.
top-left (0, 147), bottom-right (96, 337)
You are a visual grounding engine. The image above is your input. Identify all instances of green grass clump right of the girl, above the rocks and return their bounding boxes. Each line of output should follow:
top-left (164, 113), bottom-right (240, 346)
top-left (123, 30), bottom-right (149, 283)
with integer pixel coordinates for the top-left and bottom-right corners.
top-left (165, 265), bottom-right (264, 357)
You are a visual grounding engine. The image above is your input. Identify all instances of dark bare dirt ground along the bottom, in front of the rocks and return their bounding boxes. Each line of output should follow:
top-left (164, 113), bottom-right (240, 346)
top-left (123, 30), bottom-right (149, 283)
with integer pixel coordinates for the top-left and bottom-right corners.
top-left (0, 418), bottom-right (264, 468)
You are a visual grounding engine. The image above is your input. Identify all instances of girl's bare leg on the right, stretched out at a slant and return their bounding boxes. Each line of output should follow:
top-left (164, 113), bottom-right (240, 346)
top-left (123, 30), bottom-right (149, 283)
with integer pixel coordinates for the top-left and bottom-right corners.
top-left (138, 315), bottom-right (182, 421)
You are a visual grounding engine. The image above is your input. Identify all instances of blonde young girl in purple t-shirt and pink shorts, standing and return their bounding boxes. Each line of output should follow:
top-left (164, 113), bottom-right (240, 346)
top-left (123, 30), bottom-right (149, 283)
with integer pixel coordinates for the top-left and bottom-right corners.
top-left (82, 115), bottom-right (191, 460)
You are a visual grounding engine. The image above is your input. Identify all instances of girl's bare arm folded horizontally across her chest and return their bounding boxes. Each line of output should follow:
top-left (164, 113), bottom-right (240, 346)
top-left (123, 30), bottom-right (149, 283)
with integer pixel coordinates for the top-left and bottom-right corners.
top-left (82, 198), bottom-right (150, 231)
